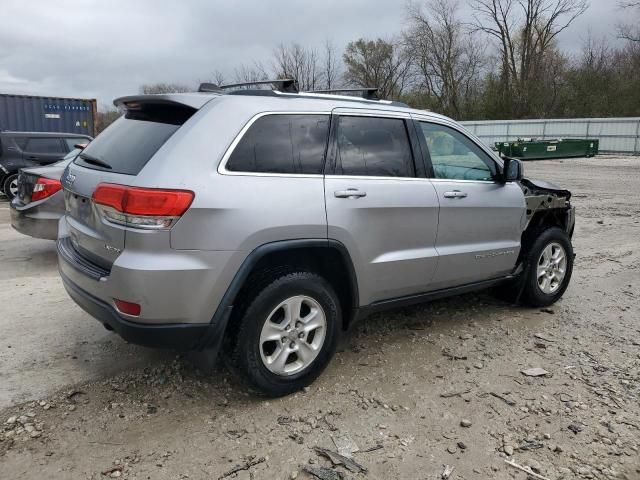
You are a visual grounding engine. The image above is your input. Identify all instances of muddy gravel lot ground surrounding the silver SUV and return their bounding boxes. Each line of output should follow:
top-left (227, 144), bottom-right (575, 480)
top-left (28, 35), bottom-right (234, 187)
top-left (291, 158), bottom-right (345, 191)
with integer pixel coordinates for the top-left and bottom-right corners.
top-left (0, 156), bottom-right (640, 480)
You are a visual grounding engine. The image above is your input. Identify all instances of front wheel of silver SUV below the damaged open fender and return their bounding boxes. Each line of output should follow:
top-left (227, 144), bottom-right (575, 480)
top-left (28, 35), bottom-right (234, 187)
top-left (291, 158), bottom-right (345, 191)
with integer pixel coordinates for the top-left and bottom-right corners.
top-left (522, 227), bottom-right (573, 307)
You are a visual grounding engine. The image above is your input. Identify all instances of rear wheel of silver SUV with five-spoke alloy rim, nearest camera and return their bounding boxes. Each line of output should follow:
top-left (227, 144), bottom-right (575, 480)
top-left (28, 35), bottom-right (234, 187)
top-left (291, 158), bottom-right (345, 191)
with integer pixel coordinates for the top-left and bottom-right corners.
top-left (225, 272), bottom-right (341, 397)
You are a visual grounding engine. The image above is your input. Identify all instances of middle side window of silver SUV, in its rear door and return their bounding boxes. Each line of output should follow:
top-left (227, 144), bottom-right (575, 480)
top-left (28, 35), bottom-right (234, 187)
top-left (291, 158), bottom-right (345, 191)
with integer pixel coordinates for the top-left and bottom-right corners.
top-left (335, 116), bottom-right (415, 177)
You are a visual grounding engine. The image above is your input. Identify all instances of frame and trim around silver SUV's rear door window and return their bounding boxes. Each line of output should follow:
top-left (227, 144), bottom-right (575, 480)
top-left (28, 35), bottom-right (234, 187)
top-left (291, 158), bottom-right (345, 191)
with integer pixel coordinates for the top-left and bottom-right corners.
top-left (324, 109), bottom-right (426, 180)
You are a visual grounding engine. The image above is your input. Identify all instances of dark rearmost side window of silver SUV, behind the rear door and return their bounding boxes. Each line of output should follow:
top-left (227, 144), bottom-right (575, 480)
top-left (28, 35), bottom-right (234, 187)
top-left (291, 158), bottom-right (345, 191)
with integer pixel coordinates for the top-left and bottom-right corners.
top-left (226, 114), bottom-right (329, 174)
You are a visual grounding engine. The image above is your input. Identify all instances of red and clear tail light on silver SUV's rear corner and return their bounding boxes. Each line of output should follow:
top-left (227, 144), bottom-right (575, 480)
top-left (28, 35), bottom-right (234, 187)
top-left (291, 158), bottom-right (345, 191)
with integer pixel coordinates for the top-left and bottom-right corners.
top-left (93, 183), bottom-right (194, 230)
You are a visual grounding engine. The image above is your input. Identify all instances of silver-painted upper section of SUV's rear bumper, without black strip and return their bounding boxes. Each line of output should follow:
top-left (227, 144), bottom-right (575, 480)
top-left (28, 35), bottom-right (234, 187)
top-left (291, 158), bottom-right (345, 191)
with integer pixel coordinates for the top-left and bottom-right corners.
top-left (58, 217), bottom-right (242, 326)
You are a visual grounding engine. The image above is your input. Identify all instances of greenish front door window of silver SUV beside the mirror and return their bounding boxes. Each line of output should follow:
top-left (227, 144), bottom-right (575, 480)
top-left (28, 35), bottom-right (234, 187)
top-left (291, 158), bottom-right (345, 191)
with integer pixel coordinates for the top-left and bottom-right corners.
top-left (420, 122), bottom-right (497, 181)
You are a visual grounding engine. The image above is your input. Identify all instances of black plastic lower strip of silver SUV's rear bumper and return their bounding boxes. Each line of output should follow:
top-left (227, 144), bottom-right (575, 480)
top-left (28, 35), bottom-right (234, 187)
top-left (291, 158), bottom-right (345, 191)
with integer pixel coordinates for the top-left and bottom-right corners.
top-left (60, 272), bottom-right (210, 350)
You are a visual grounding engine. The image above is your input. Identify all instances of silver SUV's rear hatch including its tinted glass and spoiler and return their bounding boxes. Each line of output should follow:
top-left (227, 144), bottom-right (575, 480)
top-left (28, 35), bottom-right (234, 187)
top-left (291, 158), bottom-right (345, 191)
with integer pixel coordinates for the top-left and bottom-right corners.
top-left (62, 95), bottom-right (206, 270)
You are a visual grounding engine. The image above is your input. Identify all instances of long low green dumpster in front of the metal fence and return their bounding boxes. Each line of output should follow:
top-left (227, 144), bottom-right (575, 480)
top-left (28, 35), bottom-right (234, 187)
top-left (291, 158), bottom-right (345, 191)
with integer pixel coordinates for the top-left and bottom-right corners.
top-left (495, 138), bottom-right (598, 160)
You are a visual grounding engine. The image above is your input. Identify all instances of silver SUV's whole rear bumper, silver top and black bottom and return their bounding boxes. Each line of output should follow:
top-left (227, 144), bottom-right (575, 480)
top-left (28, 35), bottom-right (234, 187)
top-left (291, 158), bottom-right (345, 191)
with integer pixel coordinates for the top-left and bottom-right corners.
top-left (57, 217), bottom-right (243, 350)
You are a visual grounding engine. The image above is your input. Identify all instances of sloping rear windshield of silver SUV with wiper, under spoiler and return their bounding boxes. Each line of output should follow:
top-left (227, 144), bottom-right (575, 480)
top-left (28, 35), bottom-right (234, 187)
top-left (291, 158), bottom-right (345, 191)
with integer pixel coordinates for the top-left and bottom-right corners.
top-left (75, 104), bottom-right (194, 175)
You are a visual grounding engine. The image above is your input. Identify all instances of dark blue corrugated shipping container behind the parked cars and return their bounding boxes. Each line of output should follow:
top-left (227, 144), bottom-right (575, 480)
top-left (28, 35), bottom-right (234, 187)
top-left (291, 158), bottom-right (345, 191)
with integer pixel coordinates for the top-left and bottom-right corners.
top-left (0, 93), bottom-right (97, 136)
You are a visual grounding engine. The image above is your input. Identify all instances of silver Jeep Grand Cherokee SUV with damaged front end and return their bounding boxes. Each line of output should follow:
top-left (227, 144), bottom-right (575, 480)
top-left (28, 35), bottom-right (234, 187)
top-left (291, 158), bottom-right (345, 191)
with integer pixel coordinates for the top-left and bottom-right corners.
top-left (58, 82), bottom-right (574, 396)
